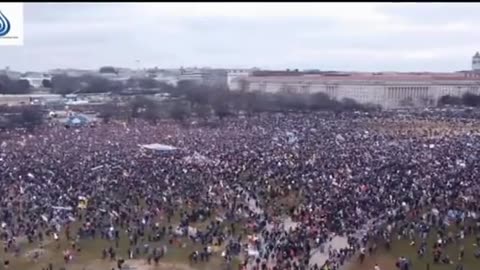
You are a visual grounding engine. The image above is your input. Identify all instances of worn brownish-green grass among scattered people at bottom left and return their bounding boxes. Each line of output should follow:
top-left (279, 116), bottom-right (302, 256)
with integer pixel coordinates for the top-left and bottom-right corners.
top-left (0, 207), bottom-right (240, 270)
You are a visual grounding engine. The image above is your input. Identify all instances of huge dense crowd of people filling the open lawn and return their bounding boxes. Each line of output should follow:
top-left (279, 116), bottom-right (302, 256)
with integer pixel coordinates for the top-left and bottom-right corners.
top-left (0, 108), bottom-right (480, 270)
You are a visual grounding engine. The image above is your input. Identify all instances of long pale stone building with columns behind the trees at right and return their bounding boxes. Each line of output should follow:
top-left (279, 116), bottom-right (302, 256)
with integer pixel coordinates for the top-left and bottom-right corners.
top-left (231, 52), bottom-right (480, 108)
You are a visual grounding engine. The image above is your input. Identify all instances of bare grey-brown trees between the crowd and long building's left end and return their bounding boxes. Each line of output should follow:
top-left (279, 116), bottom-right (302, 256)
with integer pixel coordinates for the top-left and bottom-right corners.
top-left (99, 81), bottom-right (381, 122)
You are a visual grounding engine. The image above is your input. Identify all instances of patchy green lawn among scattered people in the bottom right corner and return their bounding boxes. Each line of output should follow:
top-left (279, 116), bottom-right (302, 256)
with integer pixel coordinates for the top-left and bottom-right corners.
top-left (347, 228), bottom-right (480, 270)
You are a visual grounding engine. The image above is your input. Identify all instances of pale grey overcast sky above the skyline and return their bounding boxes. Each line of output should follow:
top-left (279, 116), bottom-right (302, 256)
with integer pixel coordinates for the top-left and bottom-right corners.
top-left (0, 3), bottom-right (480, 71)
